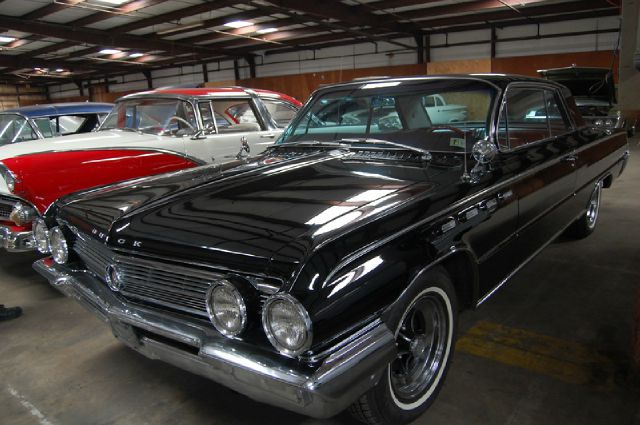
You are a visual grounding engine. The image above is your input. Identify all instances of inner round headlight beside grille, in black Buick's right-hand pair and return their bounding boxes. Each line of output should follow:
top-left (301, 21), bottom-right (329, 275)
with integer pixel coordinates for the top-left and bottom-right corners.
top-left (207, 280), bottom-right (247, 337)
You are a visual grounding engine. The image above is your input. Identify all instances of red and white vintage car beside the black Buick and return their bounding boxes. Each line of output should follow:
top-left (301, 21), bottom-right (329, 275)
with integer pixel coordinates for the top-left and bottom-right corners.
top-left (0, 87), bottom-right (301, 251)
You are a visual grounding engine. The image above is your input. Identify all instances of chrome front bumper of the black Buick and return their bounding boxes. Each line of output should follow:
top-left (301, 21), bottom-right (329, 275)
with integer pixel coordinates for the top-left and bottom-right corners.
top-left (34, 258), bottom-right (396, 418)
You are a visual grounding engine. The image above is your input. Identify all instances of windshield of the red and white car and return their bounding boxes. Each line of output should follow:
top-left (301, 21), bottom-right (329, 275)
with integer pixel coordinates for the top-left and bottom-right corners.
top-left (100, 99), bottom-right (198, 136)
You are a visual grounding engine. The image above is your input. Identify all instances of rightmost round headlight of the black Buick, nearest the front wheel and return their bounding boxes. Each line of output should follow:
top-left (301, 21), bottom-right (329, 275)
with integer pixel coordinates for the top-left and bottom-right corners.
top-left (262, 294), bottom-right (312, 357)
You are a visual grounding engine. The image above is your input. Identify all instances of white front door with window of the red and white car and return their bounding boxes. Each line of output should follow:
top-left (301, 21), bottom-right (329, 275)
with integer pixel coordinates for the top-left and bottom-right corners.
top-left (187, 96), bottom-right (275, 162)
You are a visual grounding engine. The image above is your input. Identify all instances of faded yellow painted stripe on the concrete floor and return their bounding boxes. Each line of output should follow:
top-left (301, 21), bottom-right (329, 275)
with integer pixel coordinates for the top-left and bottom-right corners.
top-left (457, 321), bottom-right (615, 389)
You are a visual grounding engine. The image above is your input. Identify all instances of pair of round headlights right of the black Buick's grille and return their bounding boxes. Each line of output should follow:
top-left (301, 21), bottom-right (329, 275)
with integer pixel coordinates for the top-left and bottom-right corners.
top-left (207, 279), bottom-right (312, 357)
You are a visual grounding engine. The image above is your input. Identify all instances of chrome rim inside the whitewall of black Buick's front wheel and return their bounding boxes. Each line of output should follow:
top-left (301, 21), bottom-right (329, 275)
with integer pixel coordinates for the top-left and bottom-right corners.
top-left (390, 294), bottom-right (450, 402)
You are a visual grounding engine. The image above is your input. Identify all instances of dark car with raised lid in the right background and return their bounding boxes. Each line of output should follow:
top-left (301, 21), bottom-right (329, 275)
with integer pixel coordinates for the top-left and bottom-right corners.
top-left (538, 65), bottom-right (637, 136)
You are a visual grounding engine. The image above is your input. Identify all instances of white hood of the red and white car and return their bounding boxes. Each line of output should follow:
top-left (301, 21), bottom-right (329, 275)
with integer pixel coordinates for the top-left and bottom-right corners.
top-left (0, 130), bottom-right (167, 160)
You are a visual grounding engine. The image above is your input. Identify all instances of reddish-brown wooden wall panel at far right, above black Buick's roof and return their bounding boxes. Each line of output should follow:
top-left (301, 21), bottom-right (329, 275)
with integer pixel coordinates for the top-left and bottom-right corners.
top-left (491, 50), bottom-right (618, 82)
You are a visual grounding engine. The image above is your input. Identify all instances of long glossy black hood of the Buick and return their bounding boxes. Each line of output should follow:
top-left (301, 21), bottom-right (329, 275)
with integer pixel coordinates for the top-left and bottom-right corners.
top-left (59, 151), bottom-right (448, 278)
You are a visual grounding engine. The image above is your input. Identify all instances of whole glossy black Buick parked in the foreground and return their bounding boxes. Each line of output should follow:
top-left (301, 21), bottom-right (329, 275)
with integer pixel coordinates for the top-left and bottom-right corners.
top-left (34, 75), bottom-right (628, 424)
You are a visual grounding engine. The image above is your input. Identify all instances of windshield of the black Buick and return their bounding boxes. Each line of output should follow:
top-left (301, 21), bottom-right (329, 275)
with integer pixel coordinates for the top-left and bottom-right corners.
top-left (278, 79), bottom-right (496, 152)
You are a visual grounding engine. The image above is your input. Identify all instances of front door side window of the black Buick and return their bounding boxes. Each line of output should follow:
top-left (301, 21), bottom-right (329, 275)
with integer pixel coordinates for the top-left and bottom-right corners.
top-left (498, 88), bottom-right (549, 149)
